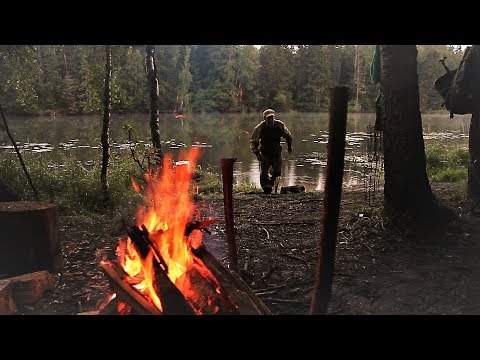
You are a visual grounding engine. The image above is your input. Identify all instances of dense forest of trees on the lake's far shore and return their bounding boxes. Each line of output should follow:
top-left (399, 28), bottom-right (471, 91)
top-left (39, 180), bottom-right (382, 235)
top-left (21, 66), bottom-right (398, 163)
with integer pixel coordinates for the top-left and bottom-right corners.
top-left (0, 45), bottom-right (463, 115)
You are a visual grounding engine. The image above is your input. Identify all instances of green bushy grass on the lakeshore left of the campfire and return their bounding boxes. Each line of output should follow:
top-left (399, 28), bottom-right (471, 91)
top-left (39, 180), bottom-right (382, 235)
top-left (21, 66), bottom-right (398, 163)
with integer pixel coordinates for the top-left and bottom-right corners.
top-left (0, 151), bottom-right (141, 214)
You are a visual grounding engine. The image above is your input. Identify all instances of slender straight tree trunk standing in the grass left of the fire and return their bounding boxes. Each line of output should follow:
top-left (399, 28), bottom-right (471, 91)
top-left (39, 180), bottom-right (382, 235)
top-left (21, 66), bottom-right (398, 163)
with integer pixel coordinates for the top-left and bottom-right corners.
top-left (100, 45), bottom-right (112, 202)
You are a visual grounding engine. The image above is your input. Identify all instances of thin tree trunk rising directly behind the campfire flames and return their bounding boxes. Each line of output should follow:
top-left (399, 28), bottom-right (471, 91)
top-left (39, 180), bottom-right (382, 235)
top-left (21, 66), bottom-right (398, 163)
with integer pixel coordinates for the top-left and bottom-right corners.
top-left (145, 45), bottom-right (163, 165)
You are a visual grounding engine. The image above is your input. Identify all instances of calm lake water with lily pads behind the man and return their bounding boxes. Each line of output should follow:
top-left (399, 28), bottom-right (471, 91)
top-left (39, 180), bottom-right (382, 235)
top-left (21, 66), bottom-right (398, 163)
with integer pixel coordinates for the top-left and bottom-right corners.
top-left (0, 111), bottom-right (470, 191)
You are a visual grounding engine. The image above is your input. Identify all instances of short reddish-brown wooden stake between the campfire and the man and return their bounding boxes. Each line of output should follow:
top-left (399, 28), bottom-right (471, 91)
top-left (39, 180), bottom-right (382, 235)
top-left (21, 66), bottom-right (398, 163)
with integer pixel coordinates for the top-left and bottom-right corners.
top-left (220, 158), bottom-right (238, 273)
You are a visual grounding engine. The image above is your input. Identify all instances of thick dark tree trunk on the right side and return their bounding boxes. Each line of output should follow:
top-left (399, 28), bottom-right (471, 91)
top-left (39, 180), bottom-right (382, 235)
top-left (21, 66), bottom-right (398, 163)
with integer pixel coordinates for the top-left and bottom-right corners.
top-left (381, 45), bottom-right (434, 216)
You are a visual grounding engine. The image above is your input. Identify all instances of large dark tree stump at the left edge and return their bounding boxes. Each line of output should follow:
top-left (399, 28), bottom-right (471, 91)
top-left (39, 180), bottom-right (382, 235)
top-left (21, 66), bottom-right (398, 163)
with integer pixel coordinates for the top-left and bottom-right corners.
top-left (0, 201), bottom-right (62, 276)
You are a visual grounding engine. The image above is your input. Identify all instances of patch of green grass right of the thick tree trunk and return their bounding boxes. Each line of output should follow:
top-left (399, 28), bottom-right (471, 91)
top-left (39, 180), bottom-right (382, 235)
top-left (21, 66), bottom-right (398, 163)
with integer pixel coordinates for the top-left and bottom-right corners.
top-left (425, 142), bottom-right (469, 182)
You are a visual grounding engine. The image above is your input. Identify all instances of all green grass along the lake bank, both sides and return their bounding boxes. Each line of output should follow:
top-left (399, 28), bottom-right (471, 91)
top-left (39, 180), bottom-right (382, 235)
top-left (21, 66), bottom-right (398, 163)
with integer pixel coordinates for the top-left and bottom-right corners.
top-left (0, 142), bottom-right (468, 215)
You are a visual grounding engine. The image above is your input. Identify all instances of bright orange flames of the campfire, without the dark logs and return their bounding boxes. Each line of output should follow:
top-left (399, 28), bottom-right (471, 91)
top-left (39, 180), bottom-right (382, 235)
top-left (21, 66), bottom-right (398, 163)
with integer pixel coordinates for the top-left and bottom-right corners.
top-left (113, 147), bottom-right (232, 314)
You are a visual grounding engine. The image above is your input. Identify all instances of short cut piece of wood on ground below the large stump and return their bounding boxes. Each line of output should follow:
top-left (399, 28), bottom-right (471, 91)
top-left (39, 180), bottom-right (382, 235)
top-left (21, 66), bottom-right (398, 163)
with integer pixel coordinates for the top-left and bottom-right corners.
top-left (8, 270), bottom-right (55, 305)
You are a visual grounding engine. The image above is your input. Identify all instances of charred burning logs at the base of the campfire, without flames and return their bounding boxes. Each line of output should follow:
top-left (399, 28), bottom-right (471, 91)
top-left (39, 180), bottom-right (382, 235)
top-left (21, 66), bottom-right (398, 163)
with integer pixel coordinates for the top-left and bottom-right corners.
top-left (101, 222), bottom-right (271, 315)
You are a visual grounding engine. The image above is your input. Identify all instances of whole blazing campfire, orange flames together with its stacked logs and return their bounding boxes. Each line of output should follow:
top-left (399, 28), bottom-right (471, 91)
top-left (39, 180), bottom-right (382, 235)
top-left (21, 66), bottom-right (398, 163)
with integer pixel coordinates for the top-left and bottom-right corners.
top-left (100, 147), bottom-right (270, 315)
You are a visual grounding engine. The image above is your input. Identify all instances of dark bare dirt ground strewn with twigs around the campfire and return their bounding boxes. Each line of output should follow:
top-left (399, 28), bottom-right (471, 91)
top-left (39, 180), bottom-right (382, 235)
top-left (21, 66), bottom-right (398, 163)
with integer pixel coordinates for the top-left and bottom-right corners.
top-left (11, 183), bottom-right (480, 315)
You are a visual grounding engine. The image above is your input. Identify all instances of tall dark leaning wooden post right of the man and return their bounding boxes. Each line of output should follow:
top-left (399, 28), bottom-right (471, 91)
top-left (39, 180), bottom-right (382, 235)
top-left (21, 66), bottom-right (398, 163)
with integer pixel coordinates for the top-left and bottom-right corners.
top-left (310, 86), bottom-right (349, 315)
